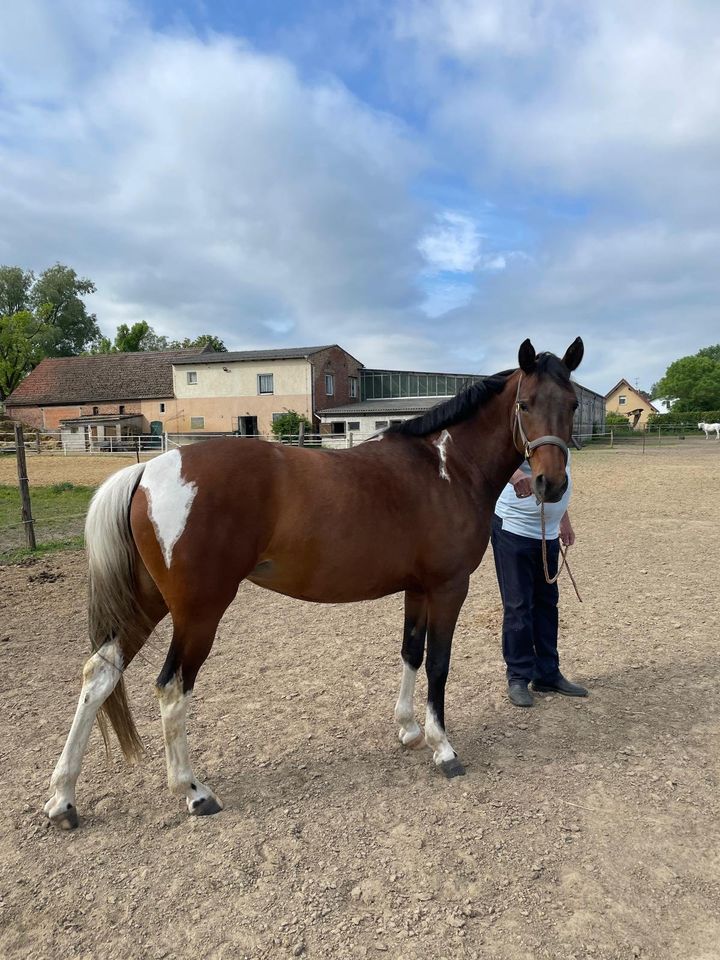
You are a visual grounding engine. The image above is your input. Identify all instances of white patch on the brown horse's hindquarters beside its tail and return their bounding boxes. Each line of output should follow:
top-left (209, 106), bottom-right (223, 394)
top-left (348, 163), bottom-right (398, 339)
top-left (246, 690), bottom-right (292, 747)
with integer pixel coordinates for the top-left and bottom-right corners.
top-left (140, 450), bottom-right (197, 570)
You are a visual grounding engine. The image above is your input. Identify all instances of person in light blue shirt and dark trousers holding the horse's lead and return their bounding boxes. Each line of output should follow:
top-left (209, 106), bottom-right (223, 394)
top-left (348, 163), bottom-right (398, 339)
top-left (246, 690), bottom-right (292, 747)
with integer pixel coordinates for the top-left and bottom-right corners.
top-left (491, 460), bottom-right (588, 707)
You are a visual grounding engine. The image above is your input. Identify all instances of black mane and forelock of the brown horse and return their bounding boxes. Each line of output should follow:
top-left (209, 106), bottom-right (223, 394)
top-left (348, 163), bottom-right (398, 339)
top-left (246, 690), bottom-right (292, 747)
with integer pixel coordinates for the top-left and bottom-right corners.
top-left (383, 353), bottom-right (570, 437)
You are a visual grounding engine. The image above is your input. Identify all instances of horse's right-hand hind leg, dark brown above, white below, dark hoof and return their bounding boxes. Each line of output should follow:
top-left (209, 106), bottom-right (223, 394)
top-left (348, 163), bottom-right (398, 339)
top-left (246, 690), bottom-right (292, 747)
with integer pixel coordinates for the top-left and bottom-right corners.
top-left (157, 601), bottom-right (229, 816)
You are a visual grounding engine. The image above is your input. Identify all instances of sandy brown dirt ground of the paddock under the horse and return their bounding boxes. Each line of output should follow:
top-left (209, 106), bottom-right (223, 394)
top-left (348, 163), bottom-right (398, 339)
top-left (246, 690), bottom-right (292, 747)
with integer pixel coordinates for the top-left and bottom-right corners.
top-left (0, 443), bottom-right (720, 960)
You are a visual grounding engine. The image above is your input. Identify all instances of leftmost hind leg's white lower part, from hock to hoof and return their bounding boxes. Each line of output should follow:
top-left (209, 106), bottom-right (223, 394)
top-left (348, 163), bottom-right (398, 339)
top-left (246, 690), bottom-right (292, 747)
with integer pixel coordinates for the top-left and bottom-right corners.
top-left (45, 640), bottom-right (123, 830)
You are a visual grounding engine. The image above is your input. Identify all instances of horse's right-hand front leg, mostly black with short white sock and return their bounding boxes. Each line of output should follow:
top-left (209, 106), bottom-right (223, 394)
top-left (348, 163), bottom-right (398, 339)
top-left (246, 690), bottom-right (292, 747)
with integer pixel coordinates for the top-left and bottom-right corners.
top-left (425, 577), bottom-right (468, 778)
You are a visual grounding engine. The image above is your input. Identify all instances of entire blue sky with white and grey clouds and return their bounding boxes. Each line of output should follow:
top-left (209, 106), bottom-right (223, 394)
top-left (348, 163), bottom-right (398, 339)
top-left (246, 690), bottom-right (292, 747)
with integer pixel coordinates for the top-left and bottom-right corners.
top-left (0, 0), bottom-right (720, 393)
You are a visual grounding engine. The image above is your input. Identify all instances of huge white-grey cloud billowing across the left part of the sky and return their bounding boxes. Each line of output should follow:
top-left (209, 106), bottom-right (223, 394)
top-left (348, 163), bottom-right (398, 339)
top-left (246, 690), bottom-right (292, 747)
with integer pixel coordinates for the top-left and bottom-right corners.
top-left (0, 4), bottom-right (424, 347)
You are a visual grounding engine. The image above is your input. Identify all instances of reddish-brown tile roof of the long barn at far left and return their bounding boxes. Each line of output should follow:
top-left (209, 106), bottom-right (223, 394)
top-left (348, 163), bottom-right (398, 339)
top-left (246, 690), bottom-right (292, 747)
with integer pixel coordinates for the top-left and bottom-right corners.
top-left (6, 349), bottom-right (198, 407)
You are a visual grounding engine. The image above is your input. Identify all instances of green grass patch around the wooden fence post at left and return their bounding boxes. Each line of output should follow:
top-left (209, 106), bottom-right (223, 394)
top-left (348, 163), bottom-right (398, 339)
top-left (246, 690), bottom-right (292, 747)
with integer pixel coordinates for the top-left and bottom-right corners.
top-left (0, 482), bottom-right (95, 563)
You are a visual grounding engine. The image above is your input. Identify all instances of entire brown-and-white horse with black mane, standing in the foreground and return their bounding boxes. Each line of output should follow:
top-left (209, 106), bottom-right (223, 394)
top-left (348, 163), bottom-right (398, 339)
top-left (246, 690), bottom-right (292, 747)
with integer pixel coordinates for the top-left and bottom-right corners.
top-left (44, 337), bottom-right (584, 829)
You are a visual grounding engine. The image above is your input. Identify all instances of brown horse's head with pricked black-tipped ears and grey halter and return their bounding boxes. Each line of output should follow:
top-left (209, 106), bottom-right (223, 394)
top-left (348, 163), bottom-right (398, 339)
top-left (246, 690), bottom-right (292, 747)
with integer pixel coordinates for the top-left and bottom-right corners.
top-left (513, 337), bottom-right (585, 503)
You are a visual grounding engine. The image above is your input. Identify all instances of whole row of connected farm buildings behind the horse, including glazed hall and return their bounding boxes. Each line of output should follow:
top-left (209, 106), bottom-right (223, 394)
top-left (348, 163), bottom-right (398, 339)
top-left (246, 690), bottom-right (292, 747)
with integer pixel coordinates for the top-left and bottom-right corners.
top-left (7, 344), bottom-right (605, 438)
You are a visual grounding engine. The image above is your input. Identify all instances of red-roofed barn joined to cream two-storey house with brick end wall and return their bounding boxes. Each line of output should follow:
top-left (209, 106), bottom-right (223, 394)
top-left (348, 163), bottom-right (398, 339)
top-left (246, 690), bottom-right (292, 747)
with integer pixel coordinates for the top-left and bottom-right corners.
top-left (7, 344), bottom-right (362, 436)
